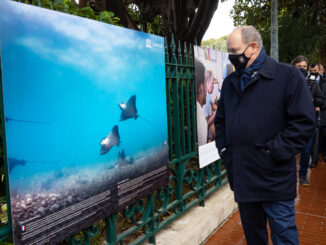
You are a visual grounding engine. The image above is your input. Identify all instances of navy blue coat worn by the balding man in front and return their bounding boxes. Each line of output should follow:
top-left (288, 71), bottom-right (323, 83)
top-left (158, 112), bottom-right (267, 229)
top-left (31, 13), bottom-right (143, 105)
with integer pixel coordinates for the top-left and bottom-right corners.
top-left (214, 56), bottom-right (316, 202)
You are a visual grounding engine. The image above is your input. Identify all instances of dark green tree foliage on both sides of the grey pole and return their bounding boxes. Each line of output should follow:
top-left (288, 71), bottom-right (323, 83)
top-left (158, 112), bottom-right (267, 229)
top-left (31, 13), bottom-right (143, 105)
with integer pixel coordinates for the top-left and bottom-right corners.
top-left (231, 0), bottom-right (326, 63)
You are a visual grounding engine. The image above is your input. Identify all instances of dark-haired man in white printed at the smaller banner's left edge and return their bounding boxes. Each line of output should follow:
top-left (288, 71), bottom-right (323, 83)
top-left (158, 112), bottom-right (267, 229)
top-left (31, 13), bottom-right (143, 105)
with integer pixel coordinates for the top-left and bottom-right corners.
top-left (195, 59), bottom-right (208, 146)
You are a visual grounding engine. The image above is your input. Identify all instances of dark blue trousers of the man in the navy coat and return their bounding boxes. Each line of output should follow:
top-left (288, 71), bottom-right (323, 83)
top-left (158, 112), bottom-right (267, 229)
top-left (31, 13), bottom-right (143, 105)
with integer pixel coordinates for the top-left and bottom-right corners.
top-left (238, 200), bottom-right (299, 245)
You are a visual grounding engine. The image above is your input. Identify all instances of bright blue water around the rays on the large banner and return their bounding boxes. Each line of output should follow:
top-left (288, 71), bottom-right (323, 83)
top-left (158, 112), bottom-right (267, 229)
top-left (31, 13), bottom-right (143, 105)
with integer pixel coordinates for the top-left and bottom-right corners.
top-left (0, 1), bottom-right (167, 189)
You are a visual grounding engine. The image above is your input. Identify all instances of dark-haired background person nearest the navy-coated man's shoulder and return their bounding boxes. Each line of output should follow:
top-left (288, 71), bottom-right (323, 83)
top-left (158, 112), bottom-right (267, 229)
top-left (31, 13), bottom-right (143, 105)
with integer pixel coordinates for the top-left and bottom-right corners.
top-left (291, 55), bottom-right (325, 186)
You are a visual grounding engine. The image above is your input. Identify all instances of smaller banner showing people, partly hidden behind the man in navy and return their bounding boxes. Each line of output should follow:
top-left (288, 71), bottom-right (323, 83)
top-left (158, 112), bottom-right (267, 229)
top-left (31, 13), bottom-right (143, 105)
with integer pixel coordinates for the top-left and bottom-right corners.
top-left (194, 46), bottom-right (233, 168)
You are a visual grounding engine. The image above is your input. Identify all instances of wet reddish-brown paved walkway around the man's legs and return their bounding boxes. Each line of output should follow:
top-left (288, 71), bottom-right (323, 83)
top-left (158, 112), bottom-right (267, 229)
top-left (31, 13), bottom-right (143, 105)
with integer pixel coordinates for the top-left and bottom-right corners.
top-left (205, 158), bottom-right (326, 245)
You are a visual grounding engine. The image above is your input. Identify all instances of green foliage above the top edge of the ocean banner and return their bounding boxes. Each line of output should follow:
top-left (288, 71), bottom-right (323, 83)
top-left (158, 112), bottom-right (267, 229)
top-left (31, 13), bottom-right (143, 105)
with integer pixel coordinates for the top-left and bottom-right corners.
top-left (15, 0), bottom-right (120, 25)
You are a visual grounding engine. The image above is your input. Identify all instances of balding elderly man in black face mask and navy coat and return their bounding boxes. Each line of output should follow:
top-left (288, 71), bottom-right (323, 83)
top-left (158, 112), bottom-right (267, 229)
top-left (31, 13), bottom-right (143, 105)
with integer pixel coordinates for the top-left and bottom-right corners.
top-left (214, 26), bottom-right (315, 245)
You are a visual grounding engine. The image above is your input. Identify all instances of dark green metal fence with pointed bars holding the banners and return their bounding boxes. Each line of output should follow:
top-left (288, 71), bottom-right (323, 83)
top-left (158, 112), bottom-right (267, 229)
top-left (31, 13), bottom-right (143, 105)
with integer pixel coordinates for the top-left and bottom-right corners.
top-left (0, 4), bottom-right (227, 245)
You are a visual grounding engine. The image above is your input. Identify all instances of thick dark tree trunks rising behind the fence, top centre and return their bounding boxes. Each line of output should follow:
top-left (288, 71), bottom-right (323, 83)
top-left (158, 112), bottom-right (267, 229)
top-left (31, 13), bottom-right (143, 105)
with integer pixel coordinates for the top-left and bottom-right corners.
top-left (106, 0), bottom-right (219, 44)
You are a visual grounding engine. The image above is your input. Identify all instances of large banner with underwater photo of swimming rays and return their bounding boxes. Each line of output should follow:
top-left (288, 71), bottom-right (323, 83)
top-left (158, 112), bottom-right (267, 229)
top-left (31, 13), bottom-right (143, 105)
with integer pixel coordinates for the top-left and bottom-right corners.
top-left (0, 0), bottom-right (169, 245)
